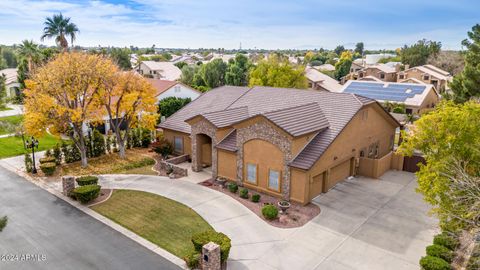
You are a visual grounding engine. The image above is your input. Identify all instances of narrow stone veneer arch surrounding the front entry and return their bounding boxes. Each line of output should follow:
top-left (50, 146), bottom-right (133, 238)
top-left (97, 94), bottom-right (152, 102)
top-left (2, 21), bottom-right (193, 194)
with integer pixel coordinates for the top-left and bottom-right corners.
top-left (190, 120), bottom-right (218, 179)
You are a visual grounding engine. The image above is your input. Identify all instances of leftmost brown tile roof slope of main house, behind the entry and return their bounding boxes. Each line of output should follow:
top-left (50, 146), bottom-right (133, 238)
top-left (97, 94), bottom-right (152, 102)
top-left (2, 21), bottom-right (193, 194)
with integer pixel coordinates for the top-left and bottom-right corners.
top-left (159, 86), bottom-right (249, 133)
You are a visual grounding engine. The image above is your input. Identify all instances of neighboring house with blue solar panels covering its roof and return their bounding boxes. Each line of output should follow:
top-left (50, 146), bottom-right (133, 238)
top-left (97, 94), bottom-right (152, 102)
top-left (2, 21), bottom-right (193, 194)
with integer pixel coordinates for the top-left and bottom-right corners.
top-left (341, 81), bottom-right (440, 114)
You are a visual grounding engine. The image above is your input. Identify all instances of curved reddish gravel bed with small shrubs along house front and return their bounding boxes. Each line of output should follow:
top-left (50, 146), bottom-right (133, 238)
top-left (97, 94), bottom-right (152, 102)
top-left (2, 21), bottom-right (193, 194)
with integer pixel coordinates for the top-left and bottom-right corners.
top-left (199, 179), bottom-right (320, 228)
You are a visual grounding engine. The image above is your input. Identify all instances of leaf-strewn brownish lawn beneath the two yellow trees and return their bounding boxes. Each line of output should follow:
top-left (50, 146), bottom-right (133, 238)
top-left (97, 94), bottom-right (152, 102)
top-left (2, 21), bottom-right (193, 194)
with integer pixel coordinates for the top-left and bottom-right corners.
top-left (61, 149), bottom-right (157, 175)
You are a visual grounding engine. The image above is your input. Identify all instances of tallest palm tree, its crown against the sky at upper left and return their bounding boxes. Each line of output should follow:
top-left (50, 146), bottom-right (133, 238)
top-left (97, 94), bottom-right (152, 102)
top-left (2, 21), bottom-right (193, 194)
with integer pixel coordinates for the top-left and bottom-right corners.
top-left (41, 13), bottom-right (80, 51)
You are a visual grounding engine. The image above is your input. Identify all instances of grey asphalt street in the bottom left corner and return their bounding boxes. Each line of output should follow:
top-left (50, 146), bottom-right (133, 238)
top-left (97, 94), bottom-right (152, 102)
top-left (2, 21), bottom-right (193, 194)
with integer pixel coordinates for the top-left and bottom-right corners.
top-left (0, 166), bottom-right (178, 270)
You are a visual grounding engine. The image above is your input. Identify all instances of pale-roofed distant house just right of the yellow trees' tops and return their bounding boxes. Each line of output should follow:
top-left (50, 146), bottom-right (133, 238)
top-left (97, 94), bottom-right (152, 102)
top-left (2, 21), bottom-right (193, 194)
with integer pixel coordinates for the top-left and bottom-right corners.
top-left (137, 61), bottom-right (182, 81)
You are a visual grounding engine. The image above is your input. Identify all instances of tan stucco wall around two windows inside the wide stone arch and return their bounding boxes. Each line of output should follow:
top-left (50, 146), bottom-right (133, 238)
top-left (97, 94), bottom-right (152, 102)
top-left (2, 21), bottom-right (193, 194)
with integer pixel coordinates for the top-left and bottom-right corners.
top-left (243, 139), bottom-right (285, 196)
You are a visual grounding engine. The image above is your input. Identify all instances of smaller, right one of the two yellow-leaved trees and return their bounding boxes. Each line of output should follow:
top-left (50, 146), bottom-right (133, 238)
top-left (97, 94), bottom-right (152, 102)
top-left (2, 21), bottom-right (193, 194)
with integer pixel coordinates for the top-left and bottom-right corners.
top-left (94, 71), bottom-right (158, 158)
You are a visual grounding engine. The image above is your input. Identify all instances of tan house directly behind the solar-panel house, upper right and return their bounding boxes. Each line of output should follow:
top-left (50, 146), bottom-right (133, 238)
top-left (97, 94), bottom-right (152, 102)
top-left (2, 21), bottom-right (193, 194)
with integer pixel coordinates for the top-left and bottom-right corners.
top-left (397, 65), bottom-right (452, 92)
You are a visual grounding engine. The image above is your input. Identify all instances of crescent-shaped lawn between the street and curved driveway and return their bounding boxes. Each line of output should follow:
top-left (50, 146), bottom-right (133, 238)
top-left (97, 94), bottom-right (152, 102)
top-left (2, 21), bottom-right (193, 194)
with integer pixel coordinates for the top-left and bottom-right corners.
top-left (91, 190), bottom-right (213, 258)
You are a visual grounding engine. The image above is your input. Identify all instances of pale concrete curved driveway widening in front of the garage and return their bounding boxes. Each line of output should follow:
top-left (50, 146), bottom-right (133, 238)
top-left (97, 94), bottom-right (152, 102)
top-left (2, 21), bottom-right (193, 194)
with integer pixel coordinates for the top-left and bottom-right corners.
top-left (68, 171), bottom-right (436, 270)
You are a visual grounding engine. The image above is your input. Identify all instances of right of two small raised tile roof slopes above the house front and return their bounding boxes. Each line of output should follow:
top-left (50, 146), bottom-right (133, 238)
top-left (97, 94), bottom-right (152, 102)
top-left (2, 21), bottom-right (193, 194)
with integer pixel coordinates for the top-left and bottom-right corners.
top-left (263, 102), bottom-right (330, 137)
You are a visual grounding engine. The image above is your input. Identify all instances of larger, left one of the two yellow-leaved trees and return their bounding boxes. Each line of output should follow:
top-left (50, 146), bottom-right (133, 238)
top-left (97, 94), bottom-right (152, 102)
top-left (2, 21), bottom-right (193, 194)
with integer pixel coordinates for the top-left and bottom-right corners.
top-left (24, 52), bottom-right (118, 167)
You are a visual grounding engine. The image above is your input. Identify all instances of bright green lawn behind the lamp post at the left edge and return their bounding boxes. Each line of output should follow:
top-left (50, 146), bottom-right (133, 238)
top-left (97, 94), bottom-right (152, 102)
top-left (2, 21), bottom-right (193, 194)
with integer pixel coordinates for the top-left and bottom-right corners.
top-left (0, 134), bottom-right (60, 158)
